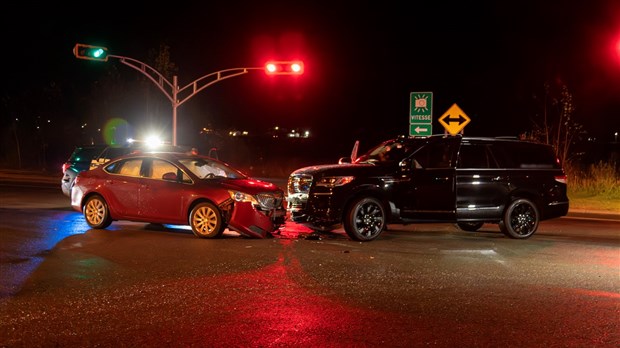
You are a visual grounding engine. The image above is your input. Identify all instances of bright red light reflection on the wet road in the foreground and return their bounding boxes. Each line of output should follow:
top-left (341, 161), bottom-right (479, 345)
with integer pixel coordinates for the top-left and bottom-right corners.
top-left (178, 240), bottom-right (422, 347)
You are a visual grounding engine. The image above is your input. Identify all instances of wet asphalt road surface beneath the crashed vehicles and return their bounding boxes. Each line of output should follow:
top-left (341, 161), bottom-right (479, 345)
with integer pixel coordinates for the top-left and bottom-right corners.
top-left (0, 173), bottom-right (620, 347)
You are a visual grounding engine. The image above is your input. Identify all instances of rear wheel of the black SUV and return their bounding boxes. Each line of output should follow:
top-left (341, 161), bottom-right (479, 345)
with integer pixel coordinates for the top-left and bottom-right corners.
top-left (499, 198), bottom-right (540, 239)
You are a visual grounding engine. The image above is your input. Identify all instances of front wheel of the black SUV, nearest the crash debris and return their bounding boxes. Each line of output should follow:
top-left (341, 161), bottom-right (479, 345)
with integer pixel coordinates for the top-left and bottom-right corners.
top-left (343, 197), bottom-right (386, 242)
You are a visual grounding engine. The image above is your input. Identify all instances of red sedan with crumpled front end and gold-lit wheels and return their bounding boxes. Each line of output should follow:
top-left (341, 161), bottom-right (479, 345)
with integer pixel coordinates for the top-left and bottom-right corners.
top-left (71, 152), bottom-right (286, 238)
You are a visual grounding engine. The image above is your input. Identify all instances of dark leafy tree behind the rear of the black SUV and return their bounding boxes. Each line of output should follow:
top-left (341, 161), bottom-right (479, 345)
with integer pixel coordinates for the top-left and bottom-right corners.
top-left (521, 82), bottom-right (585, 163)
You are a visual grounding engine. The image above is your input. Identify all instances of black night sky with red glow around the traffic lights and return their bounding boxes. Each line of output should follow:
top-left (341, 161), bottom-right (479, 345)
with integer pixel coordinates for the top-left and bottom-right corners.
top-left (0, 0), bottom-right (620, 162)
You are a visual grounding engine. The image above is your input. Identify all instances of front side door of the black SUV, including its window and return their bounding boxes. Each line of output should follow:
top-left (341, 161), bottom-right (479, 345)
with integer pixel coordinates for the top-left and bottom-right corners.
top-left (398, 137), bottom-right (460, 221)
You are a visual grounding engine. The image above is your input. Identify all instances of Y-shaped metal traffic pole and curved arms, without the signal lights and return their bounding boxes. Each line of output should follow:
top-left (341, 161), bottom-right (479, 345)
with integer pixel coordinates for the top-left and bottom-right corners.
top-left (107, 54), bottom-right (264, 146)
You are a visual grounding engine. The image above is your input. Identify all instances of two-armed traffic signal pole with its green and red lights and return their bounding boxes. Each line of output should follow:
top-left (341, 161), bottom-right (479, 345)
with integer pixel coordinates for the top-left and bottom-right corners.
top-left (73, 43), bottom-right (303, 146)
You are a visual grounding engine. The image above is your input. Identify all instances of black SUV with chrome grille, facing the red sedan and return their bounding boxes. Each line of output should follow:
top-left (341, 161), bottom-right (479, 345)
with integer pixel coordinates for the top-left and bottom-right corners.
top-left (287, 135), bottom-right (569, 241)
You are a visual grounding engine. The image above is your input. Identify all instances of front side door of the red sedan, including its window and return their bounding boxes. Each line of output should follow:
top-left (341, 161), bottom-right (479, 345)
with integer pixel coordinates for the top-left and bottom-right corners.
top-left (140, 158), bottom-right (192, 224)
